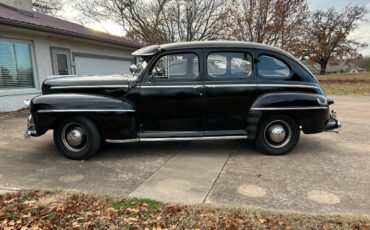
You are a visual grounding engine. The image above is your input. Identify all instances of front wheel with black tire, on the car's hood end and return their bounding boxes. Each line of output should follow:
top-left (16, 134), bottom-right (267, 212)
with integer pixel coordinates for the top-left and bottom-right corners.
top-left (54, 117), bottom-right (101, 160)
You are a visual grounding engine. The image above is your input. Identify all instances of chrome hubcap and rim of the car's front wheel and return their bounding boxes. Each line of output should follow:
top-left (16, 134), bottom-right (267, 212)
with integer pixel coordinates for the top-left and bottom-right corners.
top-left (62, 123), bottom-right (87, 152)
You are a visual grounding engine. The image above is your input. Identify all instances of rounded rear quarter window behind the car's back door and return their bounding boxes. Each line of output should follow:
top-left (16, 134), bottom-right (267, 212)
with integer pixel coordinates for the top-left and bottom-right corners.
top-left (257, 55), bottom-right (290, 79)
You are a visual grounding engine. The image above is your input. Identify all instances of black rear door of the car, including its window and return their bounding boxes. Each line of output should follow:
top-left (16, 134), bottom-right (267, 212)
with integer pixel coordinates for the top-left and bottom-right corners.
top-left (204, 49), bottom-right (257, 135)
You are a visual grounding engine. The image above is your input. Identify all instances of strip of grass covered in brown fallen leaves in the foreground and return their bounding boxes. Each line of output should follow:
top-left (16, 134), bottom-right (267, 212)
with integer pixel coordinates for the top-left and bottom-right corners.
top-left (0, 191), bottom-right (370, 230)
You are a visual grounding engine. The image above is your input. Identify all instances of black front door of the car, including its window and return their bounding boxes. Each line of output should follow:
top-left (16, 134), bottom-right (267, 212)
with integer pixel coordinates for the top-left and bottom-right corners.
top-left (140, 50), bottom-right (204, 137)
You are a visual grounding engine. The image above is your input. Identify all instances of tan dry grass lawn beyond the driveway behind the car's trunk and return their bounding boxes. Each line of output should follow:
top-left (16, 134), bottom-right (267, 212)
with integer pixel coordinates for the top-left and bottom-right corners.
top-left (317, 73), bottom-right (370, 95)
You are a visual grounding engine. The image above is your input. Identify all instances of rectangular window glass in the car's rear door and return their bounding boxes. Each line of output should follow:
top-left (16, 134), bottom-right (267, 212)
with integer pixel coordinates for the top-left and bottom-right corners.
top-left (207, 52), bottom-right (252, 79)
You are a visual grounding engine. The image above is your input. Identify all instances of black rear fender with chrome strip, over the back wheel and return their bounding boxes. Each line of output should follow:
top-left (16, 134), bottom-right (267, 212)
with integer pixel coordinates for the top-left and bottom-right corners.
top-left (247, 92), bottom-right (329, 139)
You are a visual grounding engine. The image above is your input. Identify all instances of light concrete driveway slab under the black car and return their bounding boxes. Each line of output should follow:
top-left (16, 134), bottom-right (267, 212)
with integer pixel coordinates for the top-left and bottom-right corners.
top-left (0, 96), bottom-right (370, 214)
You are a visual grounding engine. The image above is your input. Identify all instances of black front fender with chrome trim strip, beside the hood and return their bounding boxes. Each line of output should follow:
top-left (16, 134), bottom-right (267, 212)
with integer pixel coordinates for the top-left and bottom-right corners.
top-left (30, 94), bottom-right (137, 139)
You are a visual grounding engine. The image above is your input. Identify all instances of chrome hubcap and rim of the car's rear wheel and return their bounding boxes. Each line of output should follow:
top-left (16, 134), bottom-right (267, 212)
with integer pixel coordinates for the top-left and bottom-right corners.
top-left (264, 120), bottom-right (292, 148)
